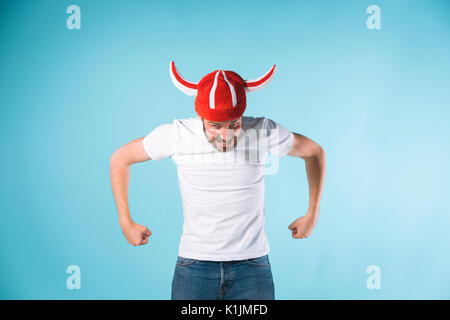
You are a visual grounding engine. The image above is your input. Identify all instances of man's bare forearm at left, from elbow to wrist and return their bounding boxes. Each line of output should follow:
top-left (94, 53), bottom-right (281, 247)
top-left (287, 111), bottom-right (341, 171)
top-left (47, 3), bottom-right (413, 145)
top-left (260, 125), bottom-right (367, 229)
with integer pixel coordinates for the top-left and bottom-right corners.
top-left (110, 159), bottom-right (132, 226)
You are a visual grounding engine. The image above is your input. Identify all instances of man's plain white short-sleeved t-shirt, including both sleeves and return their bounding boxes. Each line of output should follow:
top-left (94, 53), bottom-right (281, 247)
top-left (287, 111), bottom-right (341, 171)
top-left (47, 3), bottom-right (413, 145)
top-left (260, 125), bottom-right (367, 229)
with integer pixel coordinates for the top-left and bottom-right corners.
top-left (143, 116), bottom-right (294, 261)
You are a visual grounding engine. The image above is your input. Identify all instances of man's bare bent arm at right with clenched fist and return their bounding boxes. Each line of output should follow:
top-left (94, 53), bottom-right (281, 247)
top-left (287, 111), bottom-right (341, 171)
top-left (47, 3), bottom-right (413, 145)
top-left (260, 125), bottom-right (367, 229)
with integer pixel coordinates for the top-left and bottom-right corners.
top-left (288, 133), bottom-right (326, 239)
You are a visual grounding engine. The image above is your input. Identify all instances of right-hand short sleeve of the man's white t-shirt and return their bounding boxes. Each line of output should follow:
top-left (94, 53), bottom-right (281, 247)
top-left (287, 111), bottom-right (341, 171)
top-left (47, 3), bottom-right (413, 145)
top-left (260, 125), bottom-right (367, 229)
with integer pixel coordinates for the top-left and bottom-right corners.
top-left (264, 118), bottom-right (294, 158)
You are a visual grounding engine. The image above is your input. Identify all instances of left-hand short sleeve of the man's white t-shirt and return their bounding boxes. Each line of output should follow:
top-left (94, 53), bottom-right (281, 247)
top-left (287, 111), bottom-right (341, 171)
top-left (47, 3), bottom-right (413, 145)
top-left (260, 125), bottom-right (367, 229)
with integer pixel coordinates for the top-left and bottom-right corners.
top-left (142, 123), bottom-right (175, 161)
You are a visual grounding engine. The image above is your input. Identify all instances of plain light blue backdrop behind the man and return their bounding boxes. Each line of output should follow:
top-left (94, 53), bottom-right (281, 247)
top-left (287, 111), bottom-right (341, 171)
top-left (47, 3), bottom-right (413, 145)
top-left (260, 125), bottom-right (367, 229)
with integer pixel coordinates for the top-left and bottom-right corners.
top-left (0, 0), bottom-right (450, 299)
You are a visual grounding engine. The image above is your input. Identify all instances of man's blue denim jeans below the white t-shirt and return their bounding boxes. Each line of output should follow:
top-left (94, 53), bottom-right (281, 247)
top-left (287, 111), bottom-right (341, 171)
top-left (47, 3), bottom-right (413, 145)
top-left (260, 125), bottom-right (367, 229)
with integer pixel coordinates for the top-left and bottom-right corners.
top-left (172, 255), bottom-right (275, 300)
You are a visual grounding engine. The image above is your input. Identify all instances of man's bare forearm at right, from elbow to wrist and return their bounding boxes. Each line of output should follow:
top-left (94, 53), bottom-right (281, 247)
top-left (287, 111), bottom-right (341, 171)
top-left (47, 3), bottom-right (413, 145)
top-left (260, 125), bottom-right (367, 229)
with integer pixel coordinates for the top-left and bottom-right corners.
top-left (305, 149), bottom-right (326, 218)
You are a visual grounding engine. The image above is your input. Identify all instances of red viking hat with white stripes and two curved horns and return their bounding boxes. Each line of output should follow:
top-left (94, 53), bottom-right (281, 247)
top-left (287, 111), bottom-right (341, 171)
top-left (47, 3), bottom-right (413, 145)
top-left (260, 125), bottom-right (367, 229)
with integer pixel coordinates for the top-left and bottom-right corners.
top-left (170, 61), bottom-right (276, 121)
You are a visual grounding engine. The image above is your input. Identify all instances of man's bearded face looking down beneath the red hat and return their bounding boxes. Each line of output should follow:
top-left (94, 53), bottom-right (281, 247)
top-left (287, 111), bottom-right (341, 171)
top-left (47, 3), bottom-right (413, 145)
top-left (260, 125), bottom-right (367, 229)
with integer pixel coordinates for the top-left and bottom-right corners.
top-left (202, 117), bottom-right (242, 152)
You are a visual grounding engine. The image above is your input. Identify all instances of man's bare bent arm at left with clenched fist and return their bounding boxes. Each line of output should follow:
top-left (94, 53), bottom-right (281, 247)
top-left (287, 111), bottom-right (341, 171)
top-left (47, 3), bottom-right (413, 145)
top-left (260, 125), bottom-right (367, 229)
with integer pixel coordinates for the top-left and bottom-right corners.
top-left (110, 137), bottom-right (151, 246)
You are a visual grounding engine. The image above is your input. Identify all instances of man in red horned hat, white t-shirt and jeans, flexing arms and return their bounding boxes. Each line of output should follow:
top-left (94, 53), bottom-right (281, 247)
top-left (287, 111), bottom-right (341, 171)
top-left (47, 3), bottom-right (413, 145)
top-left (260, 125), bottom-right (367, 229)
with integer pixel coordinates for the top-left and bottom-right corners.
top-left (110, 62), bottom-right (325, 299)
